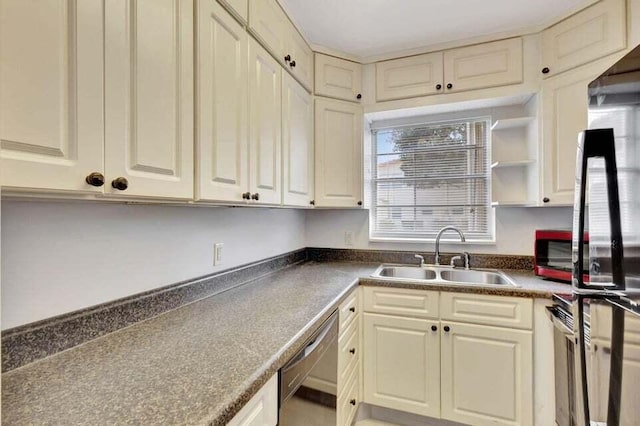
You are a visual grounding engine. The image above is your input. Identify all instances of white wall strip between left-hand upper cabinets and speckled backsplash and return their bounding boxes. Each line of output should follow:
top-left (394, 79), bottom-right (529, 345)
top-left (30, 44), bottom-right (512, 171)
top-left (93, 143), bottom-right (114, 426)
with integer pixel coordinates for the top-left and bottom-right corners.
top-left (1, 200), bottom-right (305, 329)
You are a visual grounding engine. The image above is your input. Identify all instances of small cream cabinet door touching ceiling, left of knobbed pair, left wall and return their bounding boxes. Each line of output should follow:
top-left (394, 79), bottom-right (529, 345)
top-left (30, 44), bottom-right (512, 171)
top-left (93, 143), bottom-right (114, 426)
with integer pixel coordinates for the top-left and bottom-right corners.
top-left (249, 0), bottom-right (284, 61)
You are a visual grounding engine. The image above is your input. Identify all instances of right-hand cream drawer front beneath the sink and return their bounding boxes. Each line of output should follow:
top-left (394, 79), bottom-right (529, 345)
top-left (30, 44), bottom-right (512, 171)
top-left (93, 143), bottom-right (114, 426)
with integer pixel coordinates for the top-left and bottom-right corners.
top-left (440, 292), bottom-right (533, 330)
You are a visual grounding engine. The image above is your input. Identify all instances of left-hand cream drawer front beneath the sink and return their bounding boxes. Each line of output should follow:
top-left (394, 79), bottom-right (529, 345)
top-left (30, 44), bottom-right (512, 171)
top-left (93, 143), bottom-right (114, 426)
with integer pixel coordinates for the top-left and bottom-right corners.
top-left (364, 287), bottom-right (439, 319)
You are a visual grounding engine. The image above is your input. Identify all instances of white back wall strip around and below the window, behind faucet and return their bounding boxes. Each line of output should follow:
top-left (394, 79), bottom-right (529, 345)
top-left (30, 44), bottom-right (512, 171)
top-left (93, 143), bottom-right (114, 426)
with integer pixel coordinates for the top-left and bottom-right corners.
top-left (306, 207), bottom-right (573, 256)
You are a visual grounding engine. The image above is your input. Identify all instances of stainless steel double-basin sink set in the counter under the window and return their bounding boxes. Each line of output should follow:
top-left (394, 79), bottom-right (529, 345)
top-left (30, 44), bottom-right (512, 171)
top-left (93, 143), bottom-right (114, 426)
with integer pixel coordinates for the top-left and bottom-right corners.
top-left (373, 265), bottom-right (517, 287)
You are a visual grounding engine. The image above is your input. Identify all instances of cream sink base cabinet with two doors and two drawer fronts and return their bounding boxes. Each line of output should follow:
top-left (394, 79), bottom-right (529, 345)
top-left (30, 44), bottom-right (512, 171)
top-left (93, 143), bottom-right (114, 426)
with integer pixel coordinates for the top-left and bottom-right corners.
top-left (363, 287), bottom-right (533, 425)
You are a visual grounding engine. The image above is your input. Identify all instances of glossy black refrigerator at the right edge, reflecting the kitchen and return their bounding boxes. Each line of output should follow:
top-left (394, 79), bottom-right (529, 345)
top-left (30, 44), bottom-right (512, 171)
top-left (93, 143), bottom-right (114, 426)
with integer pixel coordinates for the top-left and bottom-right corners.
top-left (569, 46), bottom-right (640, 426)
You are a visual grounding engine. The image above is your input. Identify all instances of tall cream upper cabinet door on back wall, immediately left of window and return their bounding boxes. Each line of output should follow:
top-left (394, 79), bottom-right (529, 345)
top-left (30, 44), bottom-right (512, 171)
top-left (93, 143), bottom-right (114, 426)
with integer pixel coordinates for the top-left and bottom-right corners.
top-left (315, 98), bottom-right (362, 207)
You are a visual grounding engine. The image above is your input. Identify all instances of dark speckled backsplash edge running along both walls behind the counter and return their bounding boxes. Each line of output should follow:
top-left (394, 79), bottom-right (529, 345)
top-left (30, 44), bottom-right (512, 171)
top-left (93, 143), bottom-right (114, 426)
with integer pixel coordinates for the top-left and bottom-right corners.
top-left (1, 247), bottom-right (533, 373)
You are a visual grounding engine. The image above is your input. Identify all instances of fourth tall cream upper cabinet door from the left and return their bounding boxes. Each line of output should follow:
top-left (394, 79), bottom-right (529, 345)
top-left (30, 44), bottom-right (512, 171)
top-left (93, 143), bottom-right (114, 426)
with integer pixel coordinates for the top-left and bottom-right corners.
top-left (249, 40), bottom-right (282, 204)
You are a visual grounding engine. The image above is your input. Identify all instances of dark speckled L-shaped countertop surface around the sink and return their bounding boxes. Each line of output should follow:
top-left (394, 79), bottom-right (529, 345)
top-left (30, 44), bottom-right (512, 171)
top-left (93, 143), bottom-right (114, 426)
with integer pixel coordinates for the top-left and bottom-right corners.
top-left (2, 262), bottom-right (570, 425)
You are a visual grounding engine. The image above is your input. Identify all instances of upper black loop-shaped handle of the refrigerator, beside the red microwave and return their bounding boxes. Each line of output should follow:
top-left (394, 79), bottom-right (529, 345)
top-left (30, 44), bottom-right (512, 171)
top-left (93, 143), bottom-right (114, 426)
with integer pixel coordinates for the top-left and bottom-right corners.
top-left (571, 129), bottom-right (625, 291)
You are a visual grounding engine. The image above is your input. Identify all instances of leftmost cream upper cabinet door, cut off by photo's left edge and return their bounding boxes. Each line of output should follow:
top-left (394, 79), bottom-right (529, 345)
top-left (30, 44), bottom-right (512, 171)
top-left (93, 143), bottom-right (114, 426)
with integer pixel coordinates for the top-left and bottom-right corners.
top-left (0, 0), bottom-right (104, 192)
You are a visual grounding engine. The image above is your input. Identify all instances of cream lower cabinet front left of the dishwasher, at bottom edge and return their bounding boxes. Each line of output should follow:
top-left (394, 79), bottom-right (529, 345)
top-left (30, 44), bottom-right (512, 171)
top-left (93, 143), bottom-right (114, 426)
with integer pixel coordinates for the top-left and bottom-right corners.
top-left (227, 374), bottom-right (278, 426)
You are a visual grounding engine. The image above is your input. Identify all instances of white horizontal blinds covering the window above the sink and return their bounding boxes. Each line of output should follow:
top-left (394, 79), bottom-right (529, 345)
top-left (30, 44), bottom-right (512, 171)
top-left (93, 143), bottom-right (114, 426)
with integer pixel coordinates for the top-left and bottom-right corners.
top-left (371, 118), bottom-right (493, 240)
